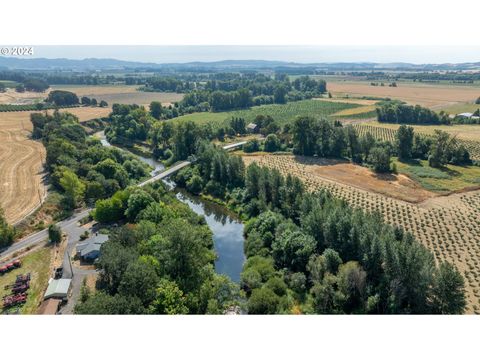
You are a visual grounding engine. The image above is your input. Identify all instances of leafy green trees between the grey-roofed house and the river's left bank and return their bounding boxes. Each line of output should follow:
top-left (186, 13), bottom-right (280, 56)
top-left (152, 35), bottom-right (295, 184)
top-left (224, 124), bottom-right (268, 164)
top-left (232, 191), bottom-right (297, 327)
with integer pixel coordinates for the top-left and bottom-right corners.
top-left (75, 184), bottom-right (241, 315)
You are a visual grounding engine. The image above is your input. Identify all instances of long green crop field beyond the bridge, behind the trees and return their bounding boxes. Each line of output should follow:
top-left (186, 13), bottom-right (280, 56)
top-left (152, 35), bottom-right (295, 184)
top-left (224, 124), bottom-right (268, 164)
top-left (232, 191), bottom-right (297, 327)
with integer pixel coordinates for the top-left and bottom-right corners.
top-left (172, 100), bottom-right (361, 126)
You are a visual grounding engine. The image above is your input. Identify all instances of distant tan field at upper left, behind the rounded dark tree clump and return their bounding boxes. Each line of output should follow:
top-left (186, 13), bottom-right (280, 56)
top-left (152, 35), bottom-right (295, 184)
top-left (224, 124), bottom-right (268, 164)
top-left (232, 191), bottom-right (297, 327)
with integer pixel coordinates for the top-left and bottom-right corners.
top-left (51, 85), bottom-right (183, 106)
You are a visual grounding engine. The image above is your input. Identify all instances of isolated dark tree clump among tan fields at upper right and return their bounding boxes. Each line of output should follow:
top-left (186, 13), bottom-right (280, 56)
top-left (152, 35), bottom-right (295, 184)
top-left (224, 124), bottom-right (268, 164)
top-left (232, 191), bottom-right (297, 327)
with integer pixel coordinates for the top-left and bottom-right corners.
top-left (377, 102), bottom-right (450, 125)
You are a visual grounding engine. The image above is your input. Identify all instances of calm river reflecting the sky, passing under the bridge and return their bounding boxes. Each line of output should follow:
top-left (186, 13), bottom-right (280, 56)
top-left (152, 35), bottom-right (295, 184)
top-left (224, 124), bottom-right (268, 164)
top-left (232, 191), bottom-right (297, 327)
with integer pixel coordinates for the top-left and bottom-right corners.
top-left (95, 131), bottom-right (245, 282)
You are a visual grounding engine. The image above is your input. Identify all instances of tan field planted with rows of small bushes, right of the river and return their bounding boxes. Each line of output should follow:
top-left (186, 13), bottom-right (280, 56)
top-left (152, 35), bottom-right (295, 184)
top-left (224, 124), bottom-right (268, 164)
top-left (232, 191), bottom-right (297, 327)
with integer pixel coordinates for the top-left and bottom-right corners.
top-left (243, 155), bottom-right (480, 314)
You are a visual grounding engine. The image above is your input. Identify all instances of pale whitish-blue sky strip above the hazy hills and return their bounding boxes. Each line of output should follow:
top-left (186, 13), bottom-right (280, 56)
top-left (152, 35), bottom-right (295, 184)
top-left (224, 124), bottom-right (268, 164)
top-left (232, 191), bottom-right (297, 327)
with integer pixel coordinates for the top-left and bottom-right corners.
top-left (21, 45), bottom-right (480, 64)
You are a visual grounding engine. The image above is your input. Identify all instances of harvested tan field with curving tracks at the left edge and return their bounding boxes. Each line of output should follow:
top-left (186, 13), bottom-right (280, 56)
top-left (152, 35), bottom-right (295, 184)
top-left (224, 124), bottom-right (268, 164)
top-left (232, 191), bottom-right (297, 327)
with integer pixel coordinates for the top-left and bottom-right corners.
top-left (0, 112), bottom-right (46, 223)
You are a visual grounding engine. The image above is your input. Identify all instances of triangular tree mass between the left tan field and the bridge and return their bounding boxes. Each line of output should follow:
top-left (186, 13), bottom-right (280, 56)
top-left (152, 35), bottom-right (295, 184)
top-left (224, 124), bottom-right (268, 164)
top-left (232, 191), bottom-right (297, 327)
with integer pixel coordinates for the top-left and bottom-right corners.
top-left (31, 111), bottom-right (148, 209)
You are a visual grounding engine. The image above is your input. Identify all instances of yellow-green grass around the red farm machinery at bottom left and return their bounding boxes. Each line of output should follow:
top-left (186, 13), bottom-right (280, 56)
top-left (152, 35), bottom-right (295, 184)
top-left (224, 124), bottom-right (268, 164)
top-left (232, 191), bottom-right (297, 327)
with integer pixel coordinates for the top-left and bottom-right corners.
top-left (0, 247), bottom-right (52, 314)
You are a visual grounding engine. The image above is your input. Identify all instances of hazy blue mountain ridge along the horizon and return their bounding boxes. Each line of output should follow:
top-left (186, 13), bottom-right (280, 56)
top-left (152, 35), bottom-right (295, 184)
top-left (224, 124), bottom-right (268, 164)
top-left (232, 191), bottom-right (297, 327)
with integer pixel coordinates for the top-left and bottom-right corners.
top-left (0, 56), bottom-right (480, 71)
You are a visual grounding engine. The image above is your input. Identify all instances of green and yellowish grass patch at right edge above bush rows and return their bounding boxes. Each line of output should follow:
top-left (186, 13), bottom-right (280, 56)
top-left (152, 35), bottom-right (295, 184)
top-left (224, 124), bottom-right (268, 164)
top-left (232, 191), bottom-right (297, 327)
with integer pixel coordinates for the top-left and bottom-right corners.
top-left (393, 158), bottom-right (480, 193)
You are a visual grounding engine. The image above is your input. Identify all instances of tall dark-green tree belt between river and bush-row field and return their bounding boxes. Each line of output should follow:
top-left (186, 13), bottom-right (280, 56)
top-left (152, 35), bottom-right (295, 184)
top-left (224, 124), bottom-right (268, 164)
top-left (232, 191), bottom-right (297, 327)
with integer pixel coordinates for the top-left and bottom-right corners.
top-left (172, 144), bottom-right (466, 314)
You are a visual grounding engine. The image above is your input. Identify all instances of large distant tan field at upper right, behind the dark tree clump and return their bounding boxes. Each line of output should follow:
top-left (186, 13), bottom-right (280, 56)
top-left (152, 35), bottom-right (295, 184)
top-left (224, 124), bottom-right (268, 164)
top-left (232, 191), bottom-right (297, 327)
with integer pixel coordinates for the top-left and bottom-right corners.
top-left (328, 81), bottom-right (479, 109)
